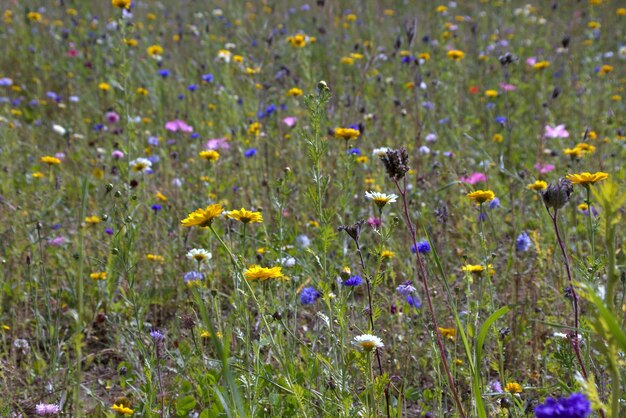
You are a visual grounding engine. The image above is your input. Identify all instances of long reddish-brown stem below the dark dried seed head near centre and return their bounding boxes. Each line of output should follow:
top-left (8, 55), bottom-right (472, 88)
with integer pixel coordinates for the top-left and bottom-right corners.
top-left (394, 177), bottom-right (466, 418)
